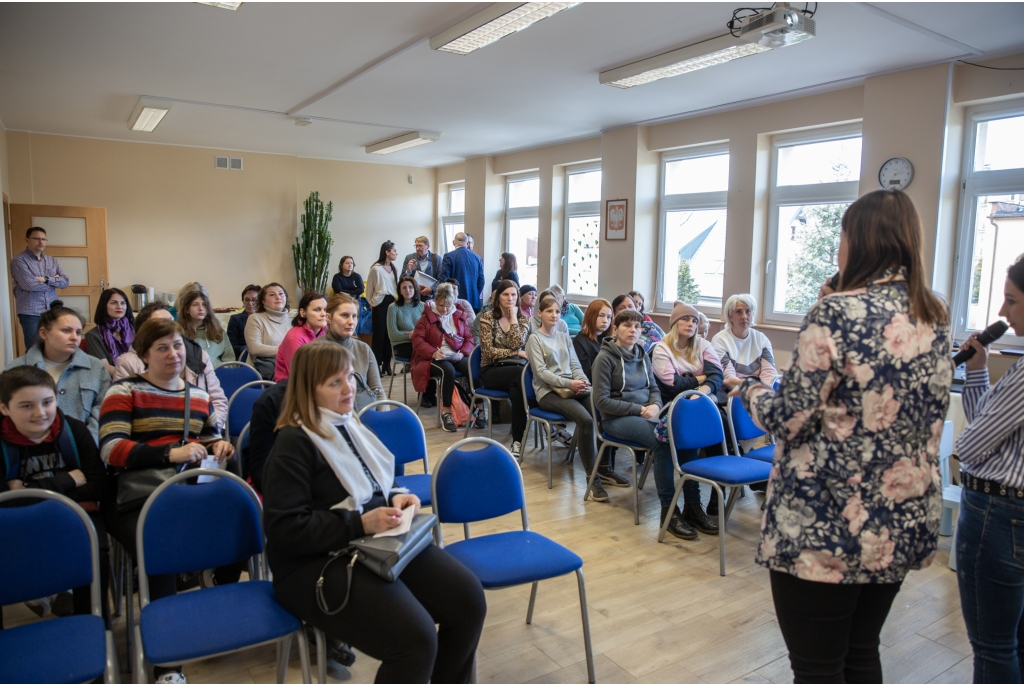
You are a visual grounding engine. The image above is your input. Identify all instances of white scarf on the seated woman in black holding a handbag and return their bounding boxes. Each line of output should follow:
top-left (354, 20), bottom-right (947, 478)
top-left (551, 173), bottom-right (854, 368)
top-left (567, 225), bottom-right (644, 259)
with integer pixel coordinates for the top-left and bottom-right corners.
top-left (299, 406), bottom-right (394, 513)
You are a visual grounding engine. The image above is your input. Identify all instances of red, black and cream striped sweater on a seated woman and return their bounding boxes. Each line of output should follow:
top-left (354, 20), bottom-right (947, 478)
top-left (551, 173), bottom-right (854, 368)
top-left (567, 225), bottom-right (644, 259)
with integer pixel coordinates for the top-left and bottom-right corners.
top-left (99, 376), bottom-right (221, 469)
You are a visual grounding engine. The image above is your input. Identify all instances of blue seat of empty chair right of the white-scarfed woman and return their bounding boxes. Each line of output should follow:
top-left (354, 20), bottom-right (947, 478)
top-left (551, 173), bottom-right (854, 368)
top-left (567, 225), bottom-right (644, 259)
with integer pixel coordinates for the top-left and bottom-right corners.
top-left (444, 530), bottom-right (583, 588)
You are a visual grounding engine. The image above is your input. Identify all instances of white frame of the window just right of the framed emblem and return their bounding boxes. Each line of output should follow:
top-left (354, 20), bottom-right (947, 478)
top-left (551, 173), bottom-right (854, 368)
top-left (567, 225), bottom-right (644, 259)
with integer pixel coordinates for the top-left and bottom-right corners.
top-left (654, 141), bottom-right (732, 318)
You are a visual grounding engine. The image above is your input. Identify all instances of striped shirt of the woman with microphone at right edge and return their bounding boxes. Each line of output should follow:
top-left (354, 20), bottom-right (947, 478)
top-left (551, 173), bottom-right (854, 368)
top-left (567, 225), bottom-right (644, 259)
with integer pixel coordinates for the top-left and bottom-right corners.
top-left (956, 359), bottom-right (1024, 487)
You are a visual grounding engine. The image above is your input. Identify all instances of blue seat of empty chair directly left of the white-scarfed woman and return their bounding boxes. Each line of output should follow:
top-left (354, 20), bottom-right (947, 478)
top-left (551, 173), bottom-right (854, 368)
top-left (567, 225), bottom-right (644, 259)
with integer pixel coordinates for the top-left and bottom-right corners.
top-left (139, 581), bottom-right (302, 665)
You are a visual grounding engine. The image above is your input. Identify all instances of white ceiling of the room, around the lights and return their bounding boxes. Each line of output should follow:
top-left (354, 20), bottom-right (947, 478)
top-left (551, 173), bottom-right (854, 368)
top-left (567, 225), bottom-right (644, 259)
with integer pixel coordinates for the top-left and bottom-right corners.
top-left (0, 0), bottom-right (1024, 166)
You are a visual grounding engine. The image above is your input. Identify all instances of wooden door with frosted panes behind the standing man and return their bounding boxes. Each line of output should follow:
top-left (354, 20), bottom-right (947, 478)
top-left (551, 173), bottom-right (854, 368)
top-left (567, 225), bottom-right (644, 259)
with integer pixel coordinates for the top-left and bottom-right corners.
top-left (7, 205), bottom-right (109, 356)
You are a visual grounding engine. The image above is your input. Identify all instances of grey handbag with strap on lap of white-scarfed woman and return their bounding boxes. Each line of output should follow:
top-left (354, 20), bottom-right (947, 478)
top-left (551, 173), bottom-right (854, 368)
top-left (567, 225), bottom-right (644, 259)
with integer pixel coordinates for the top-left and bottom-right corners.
top-left (316, 507), bottom-right (437, 616)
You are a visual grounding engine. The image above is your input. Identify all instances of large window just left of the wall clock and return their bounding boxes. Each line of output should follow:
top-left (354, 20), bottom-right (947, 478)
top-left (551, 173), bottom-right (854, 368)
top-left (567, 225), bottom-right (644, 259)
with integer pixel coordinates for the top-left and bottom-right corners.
top-left (764, 125), bottom-right (861, 325)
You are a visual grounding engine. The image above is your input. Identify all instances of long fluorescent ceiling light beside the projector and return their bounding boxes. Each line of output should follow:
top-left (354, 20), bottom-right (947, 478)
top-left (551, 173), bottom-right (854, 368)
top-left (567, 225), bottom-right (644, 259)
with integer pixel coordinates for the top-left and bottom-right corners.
top-left (600, 35), bottom-right (771, 88)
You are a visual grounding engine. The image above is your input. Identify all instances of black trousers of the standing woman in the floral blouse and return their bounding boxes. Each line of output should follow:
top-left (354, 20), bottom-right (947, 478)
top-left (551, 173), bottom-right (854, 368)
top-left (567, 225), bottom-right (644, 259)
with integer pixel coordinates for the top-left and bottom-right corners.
top-left (771, 570), bottom-right (901, 683)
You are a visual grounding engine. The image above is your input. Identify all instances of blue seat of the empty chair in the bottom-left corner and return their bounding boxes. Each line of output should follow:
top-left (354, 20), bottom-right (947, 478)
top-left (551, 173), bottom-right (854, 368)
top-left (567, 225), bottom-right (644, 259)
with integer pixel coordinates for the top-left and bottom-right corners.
top-left (0, 614), bottom-right (106, 683)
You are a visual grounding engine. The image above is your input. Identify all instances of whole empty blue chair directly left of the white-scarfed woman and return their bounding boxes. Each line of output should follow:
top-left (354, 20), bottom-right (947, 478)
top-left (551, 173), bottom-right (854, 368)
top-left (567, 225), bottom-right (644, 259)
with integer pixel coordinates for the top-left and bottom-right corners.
top-left (133, 469), bottom-right (311, 683)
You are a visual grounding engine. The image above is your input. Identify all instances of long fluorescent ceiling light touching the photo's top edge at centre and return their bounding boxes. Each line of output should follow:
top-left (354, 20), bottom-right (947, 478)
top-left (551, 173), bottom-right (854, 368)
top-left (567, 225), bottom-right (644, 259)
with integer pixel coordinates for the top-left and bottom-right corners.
top-left (430, 2), bottom-right (580, 54)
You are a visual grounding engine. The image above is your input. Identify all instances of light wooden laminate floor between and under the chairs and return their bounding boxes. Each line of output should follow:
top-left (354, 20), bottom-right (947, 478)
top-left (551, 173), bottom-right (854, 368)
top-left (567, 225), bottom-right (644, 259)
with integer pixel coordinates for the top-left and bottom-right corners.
top-left (5, 376), bottom-right (972, 683)
